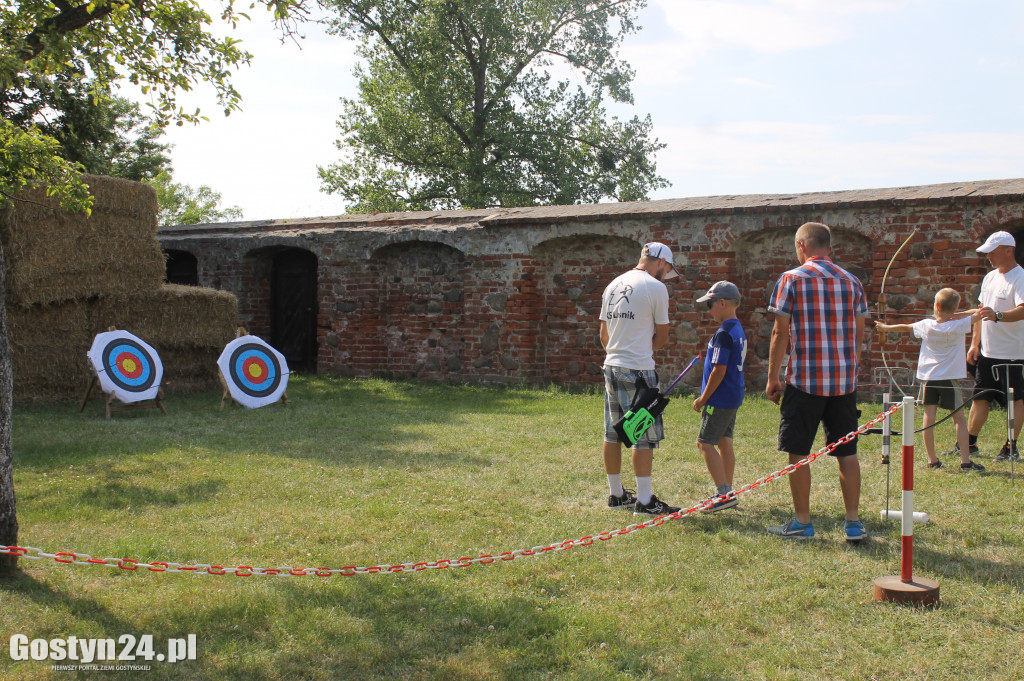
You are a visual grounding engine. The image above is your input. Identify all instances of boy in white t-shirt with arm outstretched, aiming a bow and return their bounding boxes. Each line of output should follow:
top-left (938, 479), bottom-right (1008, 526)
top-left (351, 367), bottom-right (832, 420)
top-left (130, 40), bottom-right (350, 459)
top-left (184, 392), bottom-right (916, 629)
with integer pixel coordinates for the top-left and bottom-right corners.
top-left (874, 289), bottom-right (985, 472)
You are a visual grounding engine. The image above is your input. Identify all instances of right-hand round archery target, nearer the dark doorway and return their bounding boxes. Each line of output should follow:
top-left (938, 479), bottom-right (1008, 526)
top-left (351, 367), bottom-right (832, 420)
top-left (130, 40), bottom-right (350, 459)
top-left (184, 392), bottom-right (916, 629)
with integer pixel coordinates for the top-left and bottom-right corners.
top-left (217, 336), bottom-right (289, 409)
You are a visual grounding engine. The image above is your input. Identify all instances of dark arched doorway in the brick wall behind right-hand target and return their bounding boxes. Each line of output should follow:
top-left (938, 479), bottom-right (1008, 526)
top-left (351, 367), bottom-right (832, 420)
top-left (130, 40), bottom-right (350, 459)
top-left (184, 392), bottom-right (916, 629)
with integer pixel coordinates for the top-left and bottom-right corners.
top-left (239, 246), bottom-right (319, 373)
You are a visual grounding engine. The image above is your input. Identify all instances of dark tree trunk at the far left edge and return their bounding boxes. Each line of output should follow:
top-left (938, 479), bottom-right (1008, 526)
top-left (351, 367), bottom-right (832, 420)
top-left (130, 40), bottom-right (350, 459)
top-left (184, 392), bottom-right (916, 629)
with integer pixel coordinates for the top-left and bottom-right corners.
top-left (0, 238), bottom-right (17, 574)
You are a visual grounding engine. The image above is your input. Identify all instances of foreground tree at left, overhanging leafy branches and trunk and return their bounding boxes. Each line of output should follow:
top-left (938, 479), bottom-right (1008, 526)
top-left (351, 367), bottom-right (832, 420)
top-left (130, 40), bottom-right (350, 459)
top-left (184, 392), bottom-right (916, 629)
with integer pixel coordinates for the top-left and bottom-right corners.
top-left (0, 0), bottom-right (314, 571)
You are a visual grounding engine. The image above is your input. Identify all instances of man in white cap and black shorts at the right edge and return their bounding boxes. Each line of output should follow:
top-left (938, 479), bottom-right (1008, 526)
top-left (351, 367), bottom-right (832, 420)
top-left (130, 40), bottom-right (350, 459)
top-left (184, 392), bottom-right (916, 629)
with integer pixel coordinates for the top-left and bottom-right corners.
top-left (967, 231), bottom-right (1024, 461)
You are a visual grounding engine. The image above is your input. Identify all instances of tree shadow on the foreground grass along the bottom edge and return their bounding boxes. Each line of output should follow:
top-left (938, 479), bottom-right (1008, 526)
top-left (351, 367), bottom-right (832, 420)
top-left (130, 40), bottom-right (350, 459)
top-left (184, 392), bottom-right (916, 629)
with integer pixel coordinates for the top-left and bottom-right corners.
top-left (0, 573), bottom-right (688, 681)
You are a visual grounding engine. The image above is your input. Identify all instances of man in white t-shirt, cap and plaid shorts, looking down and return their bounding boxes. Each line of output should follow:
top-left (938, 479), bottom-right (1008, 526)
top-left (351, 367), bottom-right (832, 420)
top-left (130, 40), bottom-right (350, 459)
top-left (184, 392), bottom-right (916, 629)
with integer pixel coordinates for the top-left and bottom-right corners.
top-left (601, 242), bottom-right (679, 515)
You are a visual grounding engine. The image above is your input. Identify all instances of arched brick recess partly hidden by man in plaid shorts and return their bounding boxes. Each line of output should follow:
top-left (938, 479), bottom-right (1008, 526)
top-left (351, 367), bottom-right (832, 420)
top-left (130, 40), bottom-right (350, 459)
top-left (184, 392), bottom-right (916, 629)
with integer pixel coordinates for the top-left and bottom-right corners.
top-left (531, 235), bottom-right (642, 383)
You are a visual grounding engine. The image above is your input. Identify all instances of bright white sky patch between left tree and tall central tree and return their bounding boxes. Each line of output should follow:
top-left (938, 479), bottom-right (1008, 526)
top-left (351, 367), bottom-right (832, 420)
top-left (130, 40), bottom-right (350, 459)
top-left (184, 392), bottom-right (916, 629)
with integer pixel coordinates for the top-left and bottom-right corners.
top-left (149, 3), bottom-right (356, 220)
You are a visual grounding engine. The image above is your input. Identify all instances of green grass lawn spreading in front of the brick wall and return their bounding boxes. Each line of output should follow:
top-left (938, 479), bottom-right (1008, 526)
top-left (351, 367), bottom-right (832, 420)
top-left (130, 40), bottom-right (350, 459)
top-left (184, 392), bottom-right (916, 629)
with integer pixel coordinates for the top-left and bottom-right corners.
top-left (0, 377), bottom-right (1024, 681)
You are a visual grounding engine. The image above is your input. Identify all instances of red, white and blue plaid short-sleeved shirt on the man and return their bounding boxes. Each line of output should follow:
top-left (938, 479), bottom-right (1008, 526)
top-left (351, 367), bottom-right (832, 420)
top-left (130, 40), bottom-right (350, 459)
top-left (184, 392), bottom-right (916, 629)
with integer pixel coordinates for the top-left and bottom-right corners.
top-left (768, 256), bottom-right (868, 395)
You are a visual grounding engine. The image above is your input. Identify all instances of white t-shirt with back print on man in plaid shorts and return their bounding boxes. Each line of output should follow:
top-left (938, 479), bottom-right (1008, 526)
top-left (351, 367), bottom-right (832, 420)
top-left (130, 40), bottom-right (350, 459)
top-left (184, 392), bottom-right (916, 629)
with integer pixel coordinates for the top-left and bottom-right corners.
top-left (601, 269), bottom-right (669, 370)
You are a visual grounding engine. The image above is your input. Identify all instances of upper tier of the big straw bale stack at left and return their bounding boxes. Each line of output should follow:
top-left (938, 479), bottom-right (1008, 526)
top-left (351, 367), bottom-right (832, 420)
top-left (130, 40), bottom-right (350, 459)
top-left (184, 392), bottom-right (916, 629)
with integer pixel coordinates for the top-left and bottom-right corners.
top-left (0, 175), bottom-right (166, 306)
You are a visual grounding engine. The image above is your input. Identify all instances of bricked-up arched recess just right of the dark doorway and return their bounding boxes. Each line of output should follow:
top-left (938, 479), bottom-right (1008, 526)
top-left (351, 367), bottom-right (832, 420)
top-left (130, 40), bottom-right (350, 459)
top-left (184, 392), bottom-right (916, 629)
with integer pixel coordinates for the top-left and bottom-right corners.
top-left (372, 241), bottom-right (469, 378)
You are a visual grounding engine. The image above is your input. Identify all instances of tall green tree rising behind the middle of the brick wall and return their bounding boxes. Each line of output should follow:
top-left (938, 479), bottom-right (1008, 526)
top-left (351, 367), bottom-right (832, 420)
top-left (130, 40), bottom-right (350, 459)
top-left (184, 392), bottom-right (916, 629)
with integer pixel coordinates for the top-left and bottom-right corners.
top-left (319, 0), bottom-right (668, 211)
